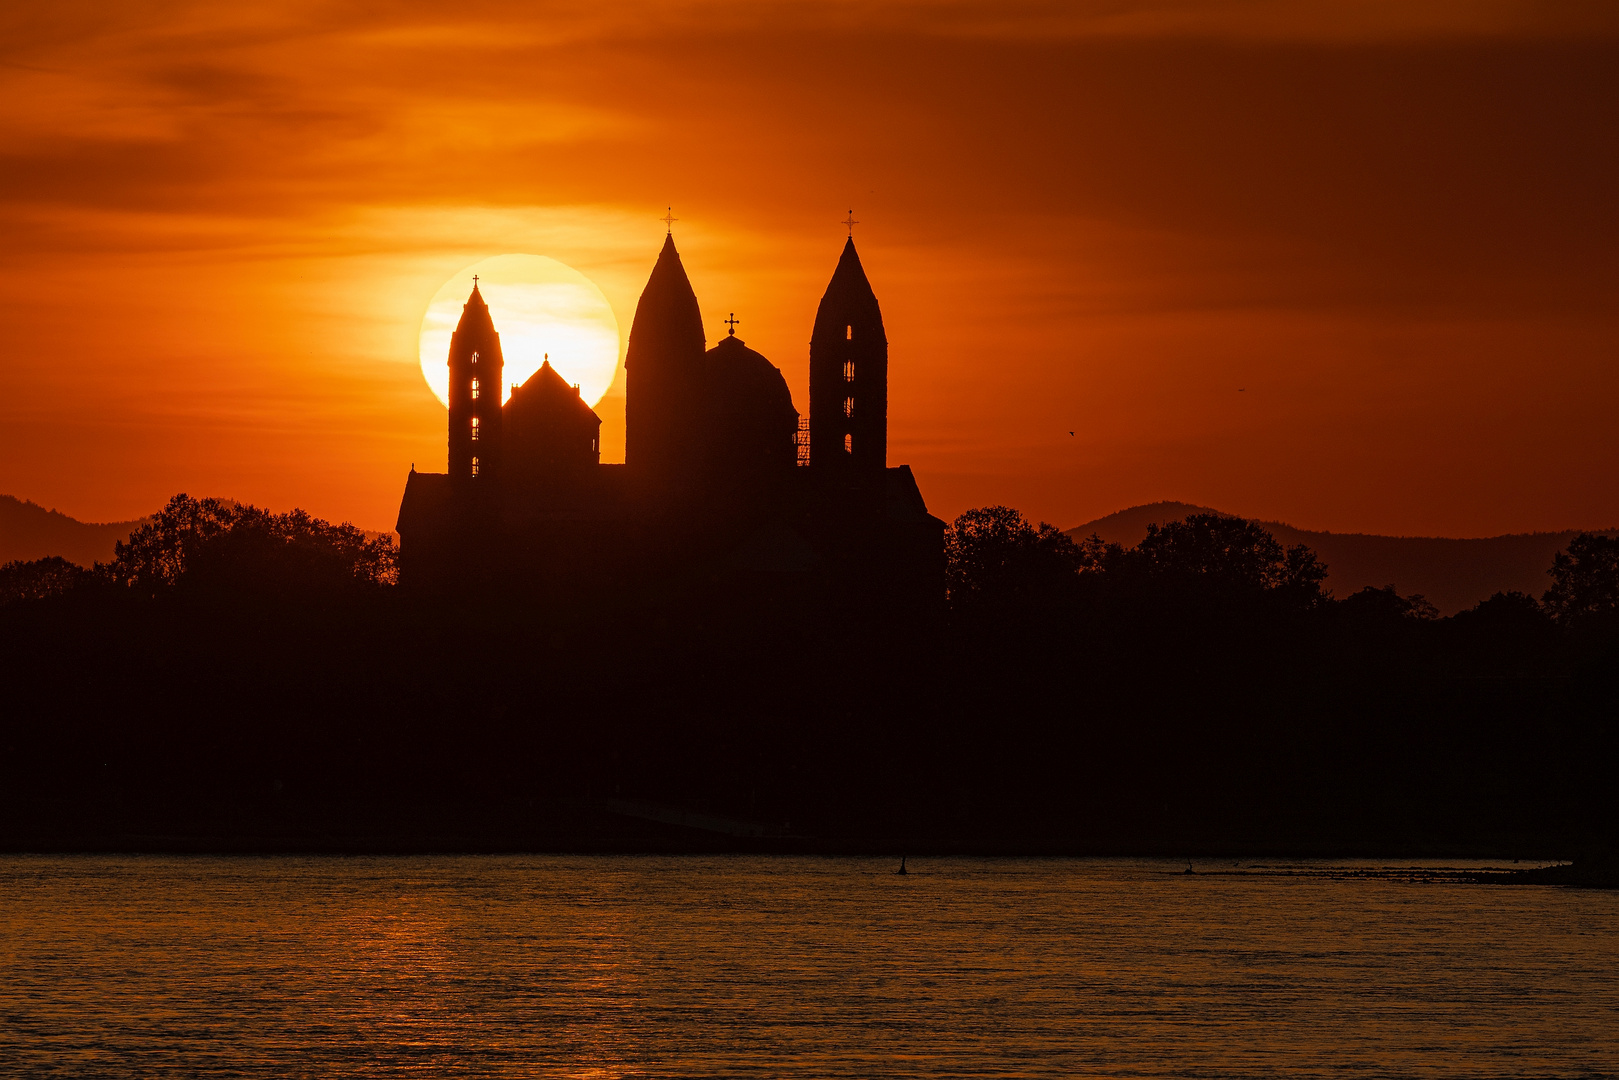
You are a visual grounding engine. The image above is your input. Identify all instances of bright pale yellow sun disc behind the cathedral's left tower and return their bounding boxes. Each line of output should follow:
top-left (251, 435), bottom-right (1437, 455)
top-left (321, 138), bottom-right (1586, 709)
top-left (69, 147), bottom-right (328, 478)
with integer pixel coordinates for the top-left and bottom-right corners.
top-left (421, 254), bottom-right (620, 405)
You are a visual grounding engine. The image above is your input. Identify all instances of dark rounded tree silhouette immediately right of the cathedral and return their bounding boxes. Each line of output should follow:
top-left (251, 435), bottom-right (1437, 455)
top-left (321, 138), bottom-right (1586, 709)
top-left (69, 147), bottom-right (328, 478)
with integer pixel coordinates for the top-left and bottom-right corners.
top-left (944, 507), bottom-right (1083, 606)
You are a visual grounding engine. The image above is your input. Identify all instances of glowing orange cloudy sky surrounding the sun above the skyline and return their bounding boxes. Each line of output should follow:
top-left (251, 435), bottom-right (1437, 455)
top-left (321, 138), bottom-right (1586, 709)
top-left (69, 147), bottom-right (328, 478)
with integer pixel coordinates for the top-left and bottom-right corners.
top-left (0, 0), bottom-right (1619, 536)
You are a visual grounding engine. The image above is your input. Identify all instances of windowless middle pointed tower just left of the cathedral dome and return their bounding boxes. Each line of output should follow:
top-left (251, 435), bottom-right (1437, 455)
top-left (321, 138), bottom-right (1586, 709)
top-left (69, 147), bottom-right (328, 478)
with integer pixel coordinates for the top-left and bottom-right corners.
top-left (623, 235), bottom-right (704, 476)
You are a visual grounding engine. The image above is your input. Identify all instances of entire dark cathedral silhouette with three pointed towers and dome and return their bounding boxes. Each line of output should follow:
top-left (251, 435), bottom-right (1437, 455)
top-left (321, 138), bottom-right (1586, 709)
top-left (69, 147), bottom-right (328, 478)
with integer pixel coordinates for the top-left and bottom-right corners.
top-left (397, 233), bottom-right (944, 609)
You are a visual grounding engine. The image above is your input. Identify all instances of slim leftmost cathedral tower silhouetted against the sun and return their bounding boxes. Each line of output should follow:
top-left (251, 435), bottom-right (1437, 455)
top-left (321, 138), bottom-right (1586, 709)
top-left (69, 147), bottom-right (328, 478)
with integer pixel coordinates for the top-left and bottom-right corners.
top-left (450, 277), bottom-right (505, 484)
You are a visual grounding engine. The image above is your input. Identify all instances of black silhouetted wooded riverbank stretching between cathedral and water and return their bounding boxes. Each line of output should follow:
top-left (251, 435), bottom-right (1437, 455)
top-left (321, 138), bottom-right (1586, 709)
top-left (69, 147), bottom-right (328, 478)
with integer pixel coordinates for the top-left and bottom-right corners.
top-left (0, 495), bottom-right (1619, 857)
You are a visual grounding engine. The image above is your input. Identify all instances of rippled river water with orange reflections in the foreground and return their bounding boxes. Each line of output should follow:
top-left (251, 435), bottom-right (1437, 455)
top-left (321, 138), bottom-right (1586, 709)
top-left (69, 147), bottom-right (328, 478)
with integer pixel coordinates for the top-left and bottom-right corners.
top-left (0, 857), bottom-right (1619, 1077)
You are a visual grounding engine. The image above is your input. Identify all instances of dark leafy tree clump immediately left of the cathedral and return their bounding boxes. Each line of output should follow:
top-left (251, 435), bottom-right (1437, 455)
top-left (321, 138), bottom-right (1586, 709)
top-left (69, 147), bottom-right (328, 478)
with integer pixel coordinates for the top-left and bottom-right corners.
top-left (104, 494), bottom-right (398, 596)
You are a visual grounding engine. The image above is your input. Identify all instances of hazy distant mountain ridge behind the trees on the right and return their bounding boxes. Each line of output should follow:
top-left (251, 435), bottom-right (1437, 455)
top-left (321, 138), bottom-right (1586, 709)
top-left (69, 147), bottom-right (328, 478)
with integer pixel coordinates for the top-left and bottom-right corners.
top-left (1065, 502), bottom-right (1619, 615)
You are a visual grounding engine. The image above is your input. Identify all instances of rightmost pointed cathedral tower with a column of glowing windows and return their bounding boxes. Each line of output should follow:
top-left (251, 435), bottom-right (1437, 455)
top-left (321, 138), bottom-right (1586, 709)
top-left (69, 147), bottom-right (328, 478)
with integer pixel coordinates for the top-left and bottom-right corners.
top-left (810, 236), bottom-right (889, 479)
